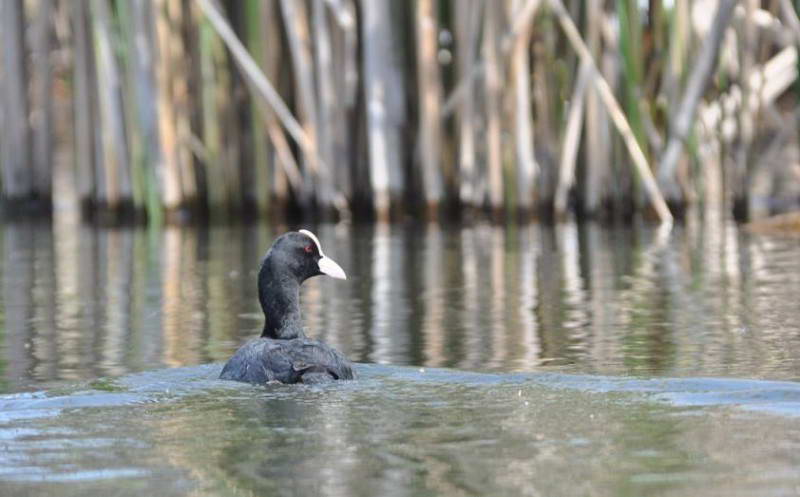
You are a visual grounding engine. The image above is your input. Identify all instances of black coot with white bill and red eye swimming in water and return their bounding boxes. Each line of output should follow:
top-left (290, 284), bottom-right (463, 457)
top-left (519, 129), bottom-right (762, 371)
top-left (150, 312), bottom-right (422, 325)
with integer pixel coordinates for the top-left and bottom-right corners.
top-left (219, 230), bottom-right (353, 383)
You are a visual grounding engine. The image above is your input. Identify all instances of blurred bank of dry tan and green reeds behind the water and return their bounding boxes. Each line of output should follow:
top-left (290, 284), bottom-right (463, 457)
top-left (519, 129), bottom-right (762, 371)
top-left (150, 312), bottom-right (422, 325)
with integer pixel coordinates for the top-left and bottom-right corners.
top-left (0, 0), bottom-right (800, 224)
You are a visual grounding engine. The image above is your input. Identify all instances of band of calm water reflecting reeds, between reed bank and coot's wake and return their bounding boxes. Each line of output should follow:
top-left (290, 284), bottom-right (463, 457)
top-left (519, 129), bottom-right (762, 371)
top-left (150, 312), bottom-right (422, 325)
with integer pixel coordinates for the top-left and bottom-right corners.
top-left (0, 223), bottom-right (800, 391)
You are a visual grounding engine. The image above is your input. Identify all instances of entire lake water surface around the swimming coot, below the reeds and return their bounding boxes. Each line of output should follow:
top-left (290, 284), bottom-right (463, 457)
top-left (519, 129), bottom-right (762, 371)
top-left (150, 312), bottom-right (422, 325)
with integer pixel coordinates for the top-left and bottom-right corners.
top-left (0, 219), bottom-right (800, 496)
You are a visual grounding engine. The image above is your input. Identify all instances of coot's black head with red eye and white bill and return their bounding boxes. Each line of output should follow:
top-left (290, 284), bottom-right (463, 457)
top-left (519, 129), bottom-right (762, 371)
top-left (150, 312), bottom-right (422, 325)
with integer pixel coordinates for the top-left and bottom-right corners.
top-left (265, 230), bottom-right (347, 283)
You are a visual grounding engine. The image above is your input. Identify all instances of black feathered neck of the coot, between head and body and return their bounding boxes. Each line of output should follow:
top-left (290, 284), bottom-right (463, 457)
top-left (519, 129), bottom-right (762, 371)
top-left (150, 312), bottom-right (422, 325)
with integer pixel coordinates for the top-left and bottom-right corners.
top-left (258, 257), bottom-right (305, 340)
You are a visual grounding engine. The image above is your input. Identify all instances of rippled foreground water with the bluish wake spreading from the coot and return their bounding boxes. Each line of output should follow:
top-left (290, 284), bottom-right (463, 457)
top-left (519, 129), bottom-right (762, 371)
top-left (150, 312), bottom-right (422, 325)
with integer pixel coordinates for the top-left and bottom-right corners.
top-left (0, 365), bottom-right (800, 496)
